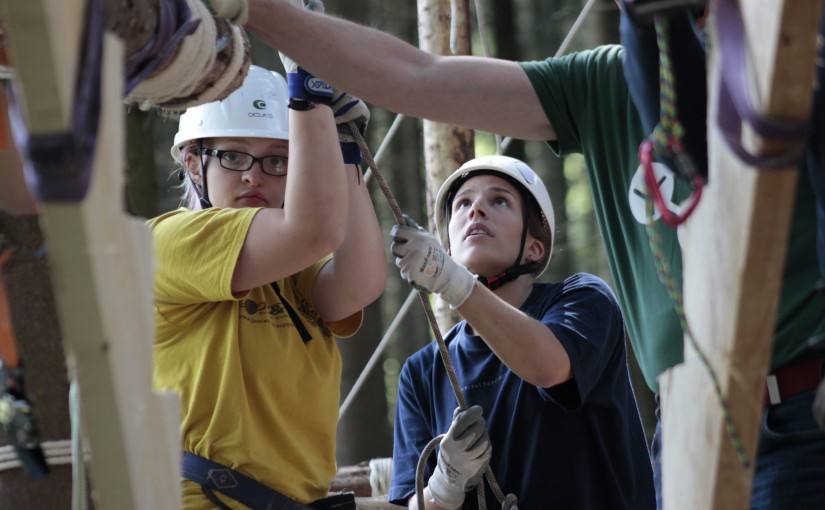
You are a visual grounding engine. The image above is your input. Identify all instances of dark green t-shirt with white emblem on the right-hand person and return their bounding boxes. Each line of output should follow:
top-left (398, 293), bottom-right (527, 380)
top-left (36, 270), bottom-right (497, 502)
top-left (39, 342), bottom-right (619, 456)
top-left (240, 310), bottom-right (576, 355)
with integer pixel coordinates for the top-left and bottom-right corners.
top-left (521, 45), bottom-right (825, 391)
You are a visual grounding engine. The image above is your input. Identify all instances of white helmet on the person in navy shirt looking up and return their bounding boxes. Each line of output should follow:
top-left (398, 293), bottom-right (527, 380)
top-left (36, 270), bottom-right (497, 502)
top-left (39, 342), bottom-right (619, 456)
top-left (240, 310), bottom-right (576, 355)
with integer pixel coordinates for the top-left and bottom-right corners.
top-left (435, 155), bottom-right (556, 276)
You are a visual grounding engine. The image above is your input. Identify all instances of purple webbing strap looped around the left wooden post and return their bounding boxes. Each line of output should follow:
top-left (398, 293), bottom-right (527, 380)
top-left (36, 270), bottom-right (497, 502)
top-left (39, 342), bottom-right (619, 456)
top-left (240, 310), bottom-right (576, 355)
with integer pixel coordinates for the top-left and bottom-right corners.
top-left (17, 0), bottom-right (104, 202)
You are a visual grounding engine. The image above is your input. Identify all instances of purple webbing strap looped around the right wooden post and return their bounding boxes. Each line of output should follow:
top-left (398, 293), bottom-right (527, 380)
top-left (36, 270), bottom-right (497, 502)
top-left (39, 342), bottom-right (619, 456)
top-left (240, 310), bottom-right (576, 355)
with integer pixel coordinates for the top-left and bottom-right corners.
top-left (715, 0), bottom-right (808, 168)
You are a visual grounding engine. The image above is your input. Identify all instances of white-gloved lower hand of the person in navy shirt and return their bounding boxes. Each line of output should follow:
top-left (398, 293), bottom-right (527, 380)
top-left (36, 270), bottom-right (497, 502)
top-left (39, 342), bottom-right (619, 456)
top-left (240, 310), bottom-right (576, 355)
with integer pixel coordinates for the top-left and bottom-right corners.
top-left (427, 406), bottom-right (493, 509)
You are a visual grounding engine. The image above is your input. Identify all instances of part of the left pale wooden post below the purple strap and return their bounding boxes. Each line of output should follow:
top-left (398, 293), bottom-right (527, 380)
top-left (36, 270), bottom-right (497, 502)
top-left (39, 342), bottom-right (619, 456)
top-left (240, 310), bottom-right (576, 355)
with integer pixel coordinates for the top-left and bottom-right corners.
top-left (36, 36), bottom-right (180, 509)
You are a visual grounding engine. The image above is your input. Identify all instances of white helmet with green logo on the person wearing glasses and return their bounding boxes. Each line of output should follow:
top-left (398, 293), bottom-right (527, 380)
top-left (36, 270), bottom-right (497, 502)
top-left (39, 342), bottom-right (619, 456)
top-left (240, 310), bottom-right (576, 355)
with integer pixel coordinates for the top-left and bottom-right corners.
top-left (171, 66), bottom-right (289, 159)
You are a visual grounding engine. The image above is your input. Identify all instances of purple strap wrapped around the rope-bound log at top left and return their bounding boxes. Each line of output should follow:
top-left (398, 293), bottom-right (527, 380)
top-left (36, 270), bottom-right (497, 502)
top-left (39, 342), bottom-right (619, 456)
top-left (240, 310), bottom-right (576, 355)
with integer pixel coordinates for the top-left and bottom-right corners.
top-left (123, 0), bottom-right (201, 96)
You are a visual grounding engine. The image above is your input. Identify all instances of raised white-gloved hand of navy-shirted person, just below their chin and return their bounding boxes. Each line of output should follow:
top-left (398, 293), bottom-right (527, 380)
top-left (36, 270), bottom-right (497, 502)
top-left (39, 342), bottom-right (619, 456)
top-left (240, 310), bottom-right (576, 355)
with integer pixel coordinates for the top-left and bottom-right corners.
top-left (390, 215), bottom-right (476, 308)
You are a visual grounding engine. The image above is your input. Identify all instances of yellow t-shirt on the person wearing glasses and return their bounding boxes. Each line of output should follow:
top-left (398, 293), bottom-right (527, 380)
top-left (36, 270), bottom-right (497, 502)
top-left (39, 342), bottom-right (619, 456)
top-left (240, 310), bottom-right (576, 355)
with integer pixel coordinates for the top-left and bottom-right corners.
top-left (148, 208), bottom-right (362, 510)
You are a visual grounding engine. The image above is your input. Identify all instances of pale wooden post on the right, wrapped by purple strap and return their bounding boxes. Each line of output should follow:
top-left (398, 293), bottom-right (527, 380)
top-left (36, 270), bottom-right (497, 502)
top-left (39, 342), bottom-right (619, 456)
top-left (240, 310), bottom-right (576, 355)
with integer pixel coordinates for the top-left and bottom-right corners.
top-left (660, 0), bottom-right (821, 510)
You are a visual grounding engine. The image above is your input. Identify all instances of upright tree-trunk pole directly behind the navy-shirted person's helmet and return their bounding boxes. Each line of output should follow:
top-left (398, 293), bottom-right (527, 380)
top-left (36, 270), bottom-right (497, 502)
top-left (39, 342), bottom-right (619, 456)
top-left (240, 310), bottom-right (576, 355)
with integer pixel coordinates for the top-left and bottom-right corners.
top-left (418, 0), bottom-right (475, 331)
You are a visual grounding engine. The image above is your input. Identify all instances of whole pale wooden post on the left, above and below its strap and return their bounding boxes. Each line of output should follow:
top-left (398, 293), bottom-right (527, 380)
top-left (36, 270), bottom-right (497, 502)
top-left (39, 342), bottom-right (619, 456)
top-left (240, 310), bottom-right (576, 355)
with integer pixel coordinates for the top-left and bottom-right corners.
top-left (3, 0), bottom-right (181, 510)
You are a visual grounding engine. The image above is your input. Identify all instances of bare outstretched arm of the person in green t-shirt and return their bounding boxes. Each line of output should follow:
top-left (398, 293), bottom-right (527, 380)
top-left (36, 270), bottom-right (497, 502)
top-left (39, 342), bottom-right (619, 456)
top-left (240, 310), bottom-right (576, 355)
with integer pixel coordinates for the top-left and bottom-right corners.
top-left (247, 0), bottom-right (555, 140)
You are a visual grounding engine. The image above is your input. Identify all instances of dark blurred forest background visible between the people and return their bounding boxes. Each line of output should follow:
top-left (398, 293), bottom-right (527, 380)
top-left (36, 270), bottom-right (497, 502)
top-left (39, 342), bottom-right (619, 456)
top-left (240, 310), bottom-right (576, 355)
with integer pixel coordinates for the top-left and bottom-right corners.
top-left (122, 0), bottom-right (653, 466)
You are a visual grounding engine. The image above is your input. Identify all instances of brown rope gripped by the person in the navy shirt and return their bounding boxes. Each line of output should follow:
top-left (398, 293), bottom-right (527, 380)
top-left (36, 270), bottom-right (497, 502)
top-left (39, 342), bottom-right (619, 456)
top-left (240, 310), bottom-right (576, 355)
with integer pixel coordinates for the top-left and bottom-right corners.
top-left (347, 121), bottom-right (517, 510)
